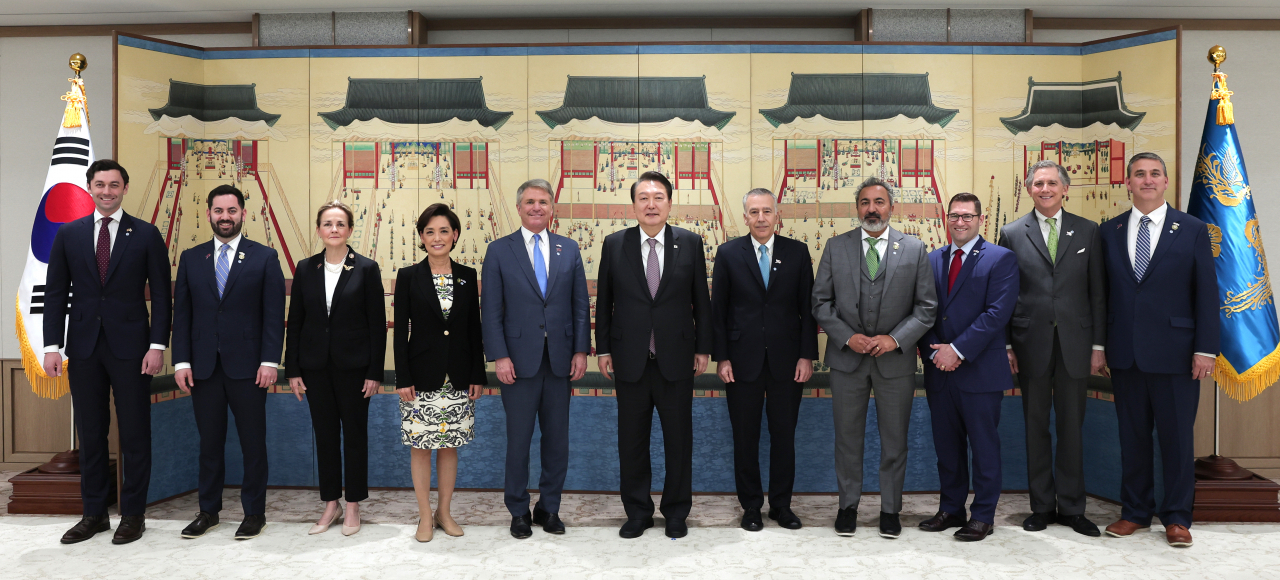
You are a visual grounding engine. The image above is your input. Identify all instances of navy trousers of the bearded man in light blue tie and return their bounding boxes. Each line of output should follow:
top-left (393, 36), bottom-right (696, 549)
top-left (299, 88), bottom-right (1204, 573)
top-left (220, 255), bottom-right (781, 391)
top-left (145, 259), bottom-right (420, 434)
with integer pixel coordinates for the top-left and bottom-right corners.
top-left (191, 356), bottom-right (266, 516)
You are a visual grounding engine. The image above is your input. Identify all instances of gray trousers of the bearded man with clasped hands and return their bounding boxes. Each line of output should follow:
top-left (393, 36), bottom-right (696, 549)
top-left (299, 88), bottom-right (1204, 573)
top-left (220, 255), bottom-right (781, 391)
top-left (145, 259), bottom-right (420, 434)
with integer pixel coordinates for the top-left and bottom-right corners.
top-left (831, 358), bottom-right (915, 513)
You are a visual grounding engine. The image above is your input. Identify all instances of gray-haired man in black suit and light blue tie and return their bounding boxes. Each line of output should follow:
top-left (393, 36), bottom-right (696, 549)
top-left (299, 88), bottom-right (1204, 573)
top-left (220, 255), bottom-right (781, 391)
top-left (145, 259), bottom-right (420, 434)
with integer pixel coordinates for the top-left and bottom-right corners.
top-left (712, 188), bottom-right (818, 531)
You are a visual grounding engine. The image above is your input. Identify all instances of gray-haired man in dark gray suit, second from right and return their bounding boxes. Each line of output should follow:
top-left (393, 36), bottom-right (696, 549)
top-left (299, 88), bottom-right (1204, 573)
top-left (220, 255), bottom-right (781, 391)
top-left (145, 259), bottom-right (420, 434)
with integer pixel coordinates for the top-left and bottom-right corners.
top-left (1000, 161), bottom-right (1107, 536)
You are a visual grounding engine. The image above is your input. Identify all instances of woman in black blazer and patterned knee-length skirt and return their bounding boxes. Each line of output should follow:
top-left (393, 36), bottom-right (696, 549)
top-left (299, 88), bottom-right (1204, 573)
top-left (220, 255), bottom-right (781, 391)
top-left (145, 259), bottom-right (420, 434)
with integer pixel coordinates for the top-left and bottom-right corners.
top-left (394, 204), bottom-right (488, 542)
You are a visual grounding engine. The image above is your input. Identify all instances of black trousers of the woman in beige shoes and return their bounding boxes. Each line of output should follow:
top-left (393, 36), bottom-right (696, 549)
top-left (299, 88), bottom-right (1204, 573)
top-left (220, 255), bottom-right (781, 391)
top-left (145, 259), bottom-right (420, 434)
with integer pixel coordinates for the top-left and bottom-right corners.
top-left (302, 364), bottom-right (369, 502)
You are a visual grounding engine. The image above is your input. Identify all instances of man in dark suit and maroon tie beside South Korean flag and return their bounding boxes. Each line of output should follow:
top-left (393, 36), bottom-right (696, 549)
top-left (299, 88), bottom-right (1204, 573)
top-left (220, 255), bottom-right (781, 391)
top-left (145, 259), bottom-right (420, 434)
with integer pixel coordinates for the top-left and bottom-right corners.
top-left (42, 159), bottom-right (170, 544)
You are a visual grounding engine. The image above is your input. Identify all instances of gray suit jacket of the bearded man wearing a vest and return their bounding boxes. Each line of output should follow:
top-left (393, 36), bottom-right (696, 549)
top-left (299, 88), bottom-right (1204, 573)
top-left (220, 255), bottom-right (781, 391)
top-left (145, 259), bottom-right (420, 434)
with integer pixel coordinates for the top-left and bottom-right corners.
top-left (813, 227), bottom-right (938, 378)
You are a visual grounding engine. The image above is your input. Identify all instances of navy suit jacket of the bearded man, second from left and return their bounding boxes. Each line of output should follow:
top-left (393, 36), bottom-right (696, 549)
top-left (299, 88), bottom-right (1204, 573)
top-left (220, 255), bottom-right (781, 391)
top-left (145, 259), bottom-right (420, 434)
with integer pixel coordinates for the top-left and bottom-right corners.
top-left (173, 238), bottom-right (284, 380)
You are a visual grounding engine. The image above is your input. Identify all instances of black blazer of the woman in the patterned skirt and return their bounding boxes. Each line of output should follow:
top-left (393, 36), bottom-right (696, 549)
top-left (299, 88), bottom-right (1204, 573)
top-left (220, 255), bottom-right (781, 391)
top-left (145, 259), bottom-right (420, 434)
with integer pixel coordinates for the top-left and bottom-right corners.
top-left (394, 261), bottom-right (489, 391)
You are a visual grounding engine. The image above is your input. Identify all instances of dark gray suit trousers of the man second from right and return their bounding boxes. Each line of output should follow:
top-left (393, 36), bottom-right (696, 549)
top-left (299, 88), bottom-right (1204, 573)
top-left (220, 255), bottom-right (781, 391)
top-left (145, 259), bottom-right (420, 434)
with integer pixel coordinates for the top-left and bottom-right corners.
top-left (1018, 332), bottom-right (1089, 516)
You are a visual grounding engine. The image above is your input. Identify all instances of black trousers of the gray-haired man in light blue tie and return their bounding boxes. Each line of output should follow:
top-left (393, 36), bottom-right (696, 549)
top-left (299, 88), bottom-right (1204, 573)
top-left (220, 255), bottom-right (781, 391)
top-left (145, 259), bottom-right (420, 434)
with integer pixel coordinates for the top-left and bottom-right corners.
top-left (726, 360), bottom-right (804, 510)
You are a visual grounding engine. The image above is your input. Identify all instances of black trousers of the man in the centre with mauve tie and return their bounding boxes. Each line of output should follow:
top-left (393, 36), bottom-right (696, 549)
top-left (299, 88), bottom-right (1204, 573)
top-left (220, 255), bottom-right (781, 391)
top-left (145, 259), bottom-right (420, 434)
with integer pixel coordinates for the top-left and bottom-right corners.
top-left (616, 358), bottom-right (694, 520)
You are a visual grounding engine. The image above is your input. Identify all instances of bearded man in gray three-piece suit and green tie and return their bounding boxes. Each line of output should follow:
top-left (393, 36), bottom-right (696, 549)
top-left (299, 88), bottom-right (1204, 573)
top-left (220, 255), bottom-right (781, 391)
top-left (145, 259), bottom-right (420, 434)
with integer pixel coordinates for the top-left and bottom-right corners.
top-left (813, 177), bottom-right (938, 538)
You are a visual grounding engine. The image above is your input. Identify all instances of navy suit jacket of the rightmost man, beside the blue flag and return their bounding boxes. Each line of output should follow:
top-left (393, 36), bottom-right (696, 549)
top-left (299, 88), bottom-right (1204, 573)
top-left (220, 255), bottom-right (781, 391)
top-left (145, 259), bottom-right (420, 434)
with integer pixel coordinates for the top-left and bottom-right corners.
top-left (1101, 207), bottom-right (1221, 374)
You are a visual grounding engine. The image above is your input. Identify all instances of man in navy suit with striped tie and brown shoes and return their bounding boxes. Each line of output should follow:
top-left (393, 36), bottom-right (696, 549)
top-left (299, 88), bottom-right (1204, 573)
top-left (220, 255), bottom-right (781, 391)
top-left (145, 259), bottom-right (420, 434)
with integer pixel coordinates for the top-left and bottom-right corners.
top-left (1101, 152), bottom-right (1220, 548)
